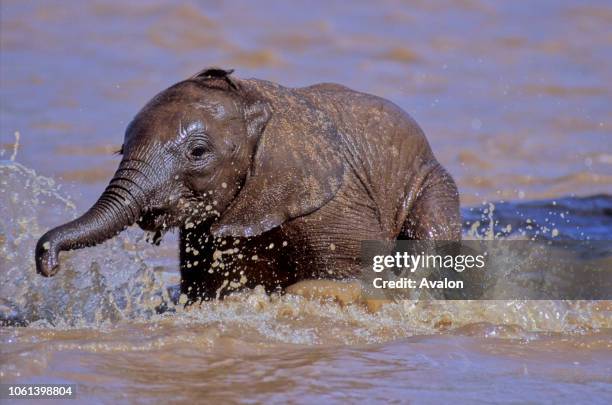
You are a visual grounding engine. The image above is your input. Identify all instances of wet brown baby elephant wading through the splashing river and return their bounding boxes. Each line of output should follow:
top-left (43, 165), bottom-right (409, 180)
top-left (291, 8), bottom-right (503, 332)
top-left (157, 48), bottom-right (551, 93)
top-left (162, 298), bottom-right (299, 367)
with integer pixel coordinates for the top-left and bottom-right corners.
top-left (36, 68), bottom-right (461, 302)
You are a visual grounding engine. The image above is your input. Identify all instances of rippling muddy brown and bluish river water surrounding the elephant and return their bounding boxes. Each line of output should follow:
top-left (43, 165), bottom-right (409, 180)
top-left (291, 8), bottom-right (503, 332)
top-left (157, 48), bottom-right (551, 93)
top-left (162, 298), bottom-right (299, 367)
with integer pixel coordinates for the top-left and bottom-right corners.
top-left (0, 0), bottom-right (612, 403)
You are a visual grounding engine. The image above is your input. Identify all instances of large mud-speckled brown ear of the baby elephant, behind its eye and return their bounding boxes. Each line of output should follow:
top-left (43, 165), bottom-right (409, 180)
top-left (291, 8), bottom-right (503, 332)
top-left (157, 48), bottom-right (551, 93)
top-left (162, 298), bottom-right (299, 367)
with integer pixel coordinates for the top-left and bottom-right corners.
top-left (212, 96), bottom-right (344, 237)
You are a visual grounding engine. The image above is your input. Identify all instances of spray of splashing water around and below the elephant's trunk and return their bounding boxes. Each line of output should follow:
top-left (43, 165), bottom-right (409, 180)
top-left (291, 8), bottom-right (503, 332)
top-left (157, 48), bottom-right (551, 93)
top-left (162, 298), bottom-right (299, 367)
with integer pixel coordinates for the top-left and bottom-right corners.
top-left (0, 161), bottom-right (170, 326)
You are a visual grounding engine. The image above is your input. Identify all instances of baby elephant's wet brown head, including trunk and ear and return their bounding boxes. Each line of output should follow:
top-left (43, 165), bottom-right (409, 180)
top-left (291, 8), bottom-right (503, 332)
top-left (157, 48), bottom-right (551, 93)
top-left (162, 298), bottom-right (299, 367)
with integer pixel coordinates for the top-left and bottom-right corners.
top-left (35, 68), bottom-right (343, 276)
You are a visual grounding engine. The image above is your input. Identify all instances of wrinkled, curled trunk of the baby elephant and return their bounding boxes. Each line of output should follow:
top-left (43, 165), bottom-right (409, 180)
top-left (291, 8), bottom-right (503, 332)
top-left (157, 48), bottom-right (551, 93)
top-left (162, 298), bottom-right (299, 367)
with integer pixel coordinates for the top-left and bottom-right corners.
top-left (36, 161), bottom-right (150, 277)
